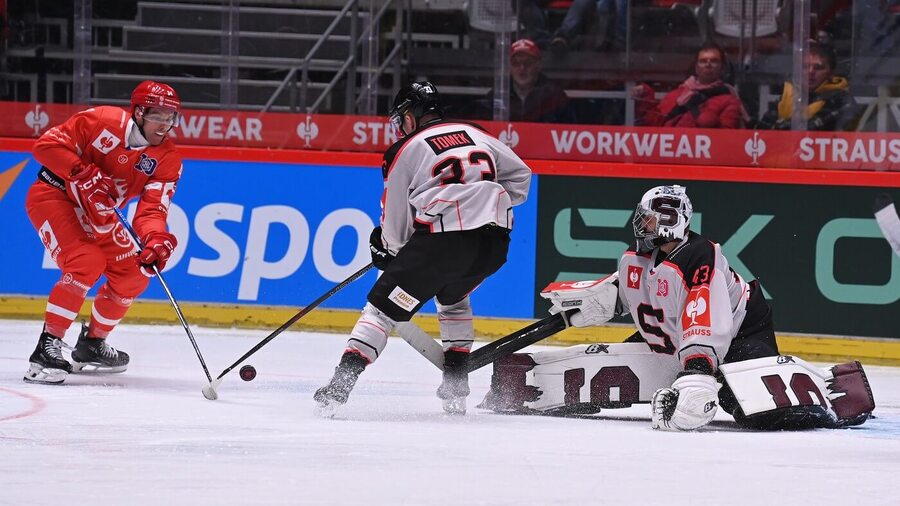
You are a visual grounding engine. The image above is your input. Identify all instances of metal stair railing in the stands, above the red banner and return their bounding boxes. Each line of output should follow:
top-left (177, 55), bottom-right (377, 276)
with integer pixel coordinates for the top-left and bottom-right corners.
top-left (261, 0), bottom-right (410, 114)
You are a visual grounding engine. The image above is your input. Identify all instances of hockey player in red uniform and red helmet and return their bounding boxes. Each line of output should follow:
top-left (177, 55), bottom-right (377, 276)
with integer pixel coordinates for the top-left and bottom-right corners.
top-left (23, 81), bottom-right (182, 384)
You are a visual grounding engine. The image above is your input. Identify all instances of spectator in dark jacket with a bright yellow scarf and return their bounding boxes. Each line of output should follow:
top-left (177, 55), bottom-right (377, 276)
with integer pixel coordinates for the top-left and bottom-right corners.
top-left (756, 43), bottom-right (859, 131)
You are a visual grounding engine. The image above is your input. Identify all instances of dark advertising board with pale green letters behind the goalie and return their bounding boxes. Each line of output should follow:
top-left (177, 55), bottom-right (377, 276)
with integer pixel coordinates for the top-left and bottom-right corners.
top-left (535, 176), bottom-right (900, 338)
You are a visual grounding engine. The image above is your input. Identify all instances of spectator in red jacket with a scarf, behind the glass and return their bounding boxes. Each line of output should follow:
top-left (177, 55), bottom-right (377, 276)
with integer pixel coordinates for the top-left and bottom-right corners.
top-left (632, 42), bottom-right (750, 128)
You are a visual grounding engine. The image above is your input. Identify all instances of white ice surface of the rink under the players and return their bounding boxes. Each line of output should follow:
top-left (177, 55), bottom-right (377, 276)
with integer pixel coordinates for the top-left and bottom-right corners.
top-left (0, 320), bottom-right (900, 506)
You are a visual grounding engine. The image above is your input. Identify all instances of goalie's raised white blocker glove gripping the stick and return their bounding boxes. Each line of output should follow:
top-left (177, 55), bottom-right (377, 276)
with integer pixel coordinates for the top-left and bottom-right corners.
top-left (541, 272), bottom-right (622, 327)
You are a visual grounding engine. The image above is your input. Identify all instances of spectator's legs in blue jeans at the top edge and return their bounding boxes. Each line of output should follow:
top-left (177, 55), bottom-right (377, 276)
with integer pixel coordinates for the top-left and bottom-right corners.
top-left (550, 0), bottom-right (628, 53)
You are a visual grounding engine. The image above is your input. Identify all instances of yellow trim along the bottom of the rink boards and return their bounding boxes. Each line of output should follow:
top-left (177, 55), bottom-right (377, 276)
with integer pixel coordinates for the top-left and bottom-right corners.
top-left (0, 296), bottom-right (900, 365)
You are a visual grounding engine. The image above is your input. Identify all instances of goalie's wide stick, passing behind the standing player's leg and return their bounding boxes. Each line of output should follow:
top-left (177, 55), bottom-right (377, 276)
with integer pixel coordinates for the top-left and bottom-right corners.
top-left (396, 309), bottom-right (577, 372)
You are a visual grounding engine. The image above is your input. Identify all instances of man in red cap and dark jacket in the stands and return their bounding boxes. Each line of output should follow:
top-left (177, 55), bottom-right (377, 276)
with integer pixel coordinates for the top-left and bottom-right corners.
top-left (509, 39), bottom-right (574, 123)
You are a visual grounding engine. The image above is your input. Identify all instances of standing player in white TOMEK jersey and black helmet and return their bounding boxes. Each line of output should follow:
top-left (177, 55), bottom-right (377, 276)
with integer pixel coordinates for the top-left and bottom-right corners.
top-left (314, 81), bottom-right (531, 415)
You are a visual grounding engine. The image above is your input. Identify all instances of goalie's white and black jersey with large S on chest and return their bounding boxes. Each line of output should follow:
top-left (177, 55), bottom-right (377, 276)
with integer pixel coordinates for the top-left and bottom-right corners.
top-left (619, 232), bottom-right (750, 371)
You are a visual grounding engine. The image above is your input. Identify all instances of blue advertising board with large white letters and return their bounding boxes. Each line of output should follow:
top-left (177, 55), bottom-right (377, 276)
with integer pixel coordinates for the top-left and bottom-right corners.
top-left (0, 151), bottom-right (537, 318)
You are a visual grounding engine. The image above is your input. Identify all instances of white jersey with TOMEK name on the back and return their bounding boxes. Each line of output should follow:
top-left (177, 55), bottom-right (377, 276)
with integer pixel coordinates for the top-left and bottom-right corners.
top-left (381, 121), bottom-right (531, 255)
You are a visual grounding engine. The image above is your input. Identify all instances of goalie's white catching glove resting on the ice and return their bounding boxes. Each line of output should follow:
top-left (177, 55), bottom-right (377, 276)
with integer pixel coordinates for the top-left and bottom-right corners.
top-left (650, 373), bottom-right (719, 431)
